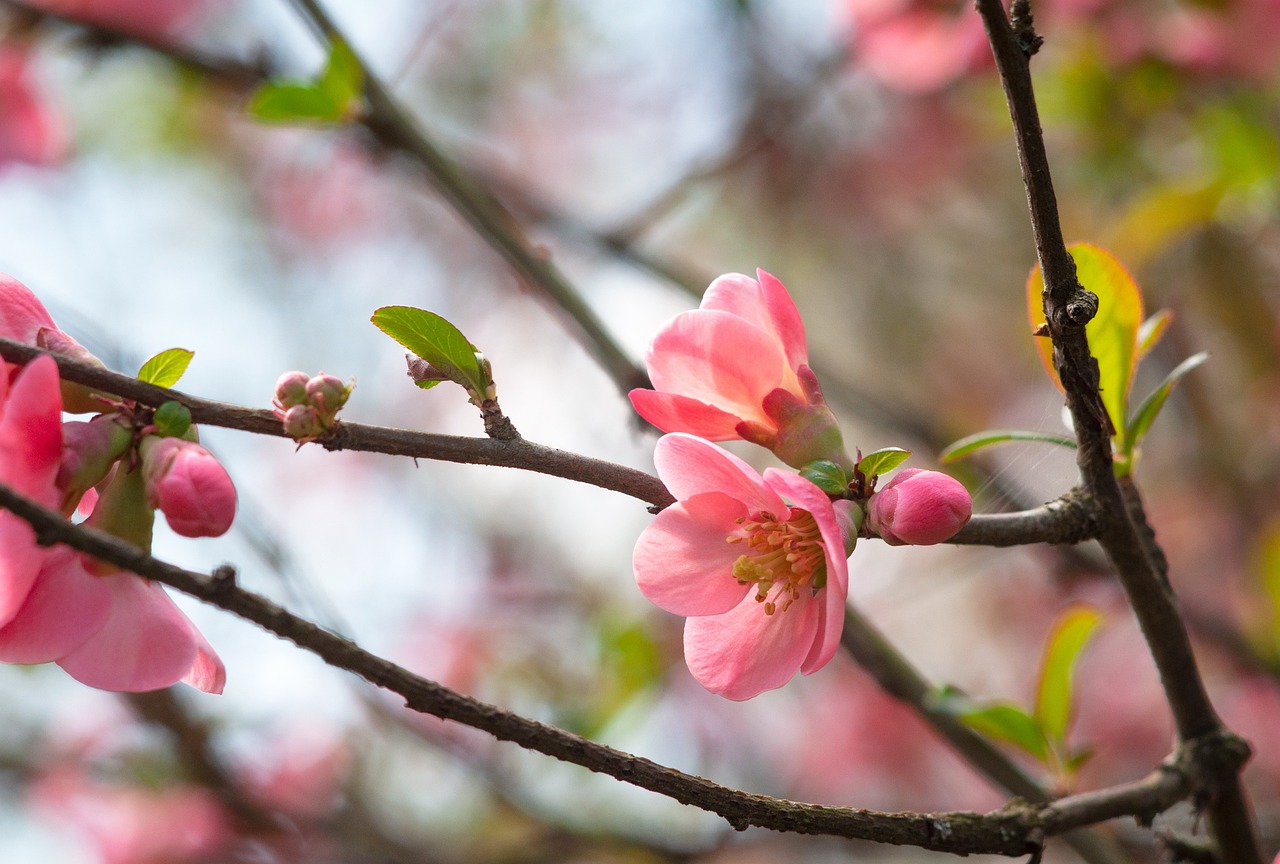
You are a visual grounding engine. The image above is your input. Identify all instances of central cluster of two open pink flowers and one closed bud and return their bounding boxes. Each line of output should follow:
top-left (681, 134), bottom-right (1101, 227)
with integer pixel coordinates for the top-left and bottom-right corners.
top-left (631, 270), bottom-right (973, 700)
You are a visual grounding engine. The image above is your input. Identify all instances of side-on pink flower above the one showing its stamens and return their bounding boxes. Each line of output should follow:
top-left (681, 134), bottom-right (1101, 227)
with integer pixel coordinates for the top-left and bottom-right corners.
top-left (631, 270), bottom-right (849, 467)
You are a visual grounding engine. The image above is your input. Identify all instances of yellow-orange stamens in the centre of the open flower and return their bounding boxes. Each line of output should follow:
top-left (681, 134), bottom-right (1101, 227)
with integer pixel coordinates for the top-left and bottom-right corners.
top-left (724, 507), bottom-right (827, 614)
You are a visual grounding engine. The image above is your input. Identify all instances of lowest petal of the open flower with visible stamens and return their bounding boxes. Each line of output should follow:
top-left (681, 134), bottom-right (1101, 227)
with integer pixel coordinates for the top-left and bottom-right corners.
top-left (685, 593), bottom-right (818, 701)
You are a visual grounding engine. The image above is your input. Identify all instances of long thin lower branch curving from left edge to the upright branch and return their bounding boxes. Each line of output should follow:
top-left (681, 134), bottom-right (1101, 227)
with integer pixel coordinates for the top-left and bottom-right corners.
top-left (0, 485), bottom-right (1218, 856)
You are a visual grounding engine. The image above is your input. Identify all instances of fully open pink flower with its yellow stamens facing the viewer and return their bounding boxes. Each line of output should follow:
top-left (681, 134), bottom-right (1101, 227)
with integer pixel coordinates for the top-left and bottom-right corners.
top-left (632, 434), bottom-right (851, 700)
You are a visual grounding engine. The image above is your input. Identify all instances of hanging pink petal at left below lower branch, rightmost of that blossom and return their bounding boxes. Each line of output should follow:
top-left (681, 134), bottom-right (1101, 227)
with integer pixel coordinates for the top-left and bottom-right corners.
top-left (58, 573), bottom-right (197, 692)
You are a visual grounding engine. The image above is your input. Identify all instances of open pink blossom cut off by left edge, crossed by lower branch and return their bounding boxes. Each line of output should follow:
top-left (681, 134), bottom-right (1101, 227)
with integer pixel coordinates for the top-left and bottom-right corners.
top-left (0, 357), bottom-right (225, 692)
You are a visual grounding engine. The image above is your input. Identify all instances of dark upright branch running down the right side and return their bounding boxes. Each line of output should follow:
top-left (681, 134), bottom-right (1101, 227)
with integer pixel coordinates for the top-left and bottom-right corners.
top-left (978, 0), bottom-right (1262, 864)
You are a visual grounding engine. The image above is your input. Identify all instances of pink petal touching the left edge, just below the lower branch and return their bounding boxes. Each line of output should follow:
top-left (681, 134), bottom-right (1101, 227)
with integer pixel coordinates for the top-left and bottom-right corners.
top-left (0, 547), bottom-right (111, 663)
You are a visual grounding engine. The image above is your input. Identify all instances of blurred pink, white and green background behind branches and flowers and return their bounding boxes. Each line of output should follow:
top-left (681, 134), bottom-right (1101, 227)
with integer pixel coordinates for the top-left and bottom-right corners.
top-left (0, 0), bottom-right (1280, 864)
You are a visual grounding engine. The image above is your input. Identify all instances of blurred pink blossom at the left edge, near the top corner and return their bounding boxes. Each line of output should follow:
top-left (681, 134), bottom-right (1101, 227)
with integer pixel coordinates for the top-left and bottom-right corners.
top-left (0, 45), bottom-right (68, 168)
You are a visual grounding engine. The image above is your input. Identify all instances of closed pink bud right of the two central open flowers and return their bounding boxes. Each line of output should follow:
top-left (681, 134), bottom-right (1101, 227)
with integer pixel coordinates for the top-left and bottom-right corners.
top-left (870, 468), bottom-right (973, 547)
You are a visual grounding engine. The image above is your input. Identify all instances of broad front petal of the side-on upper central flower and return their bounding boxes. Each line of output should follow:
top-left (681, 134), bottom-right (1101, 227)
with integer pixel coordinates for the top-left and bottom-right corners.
top-left (648, 310), bottom-right (795, 425)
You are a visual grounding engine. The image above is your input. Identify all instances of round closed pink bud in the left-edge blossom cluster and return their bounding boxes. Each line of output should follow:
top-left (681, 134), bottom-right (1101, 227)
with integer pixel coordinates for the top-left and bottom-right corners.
top-left (141, 436), bottom-right (236, 538)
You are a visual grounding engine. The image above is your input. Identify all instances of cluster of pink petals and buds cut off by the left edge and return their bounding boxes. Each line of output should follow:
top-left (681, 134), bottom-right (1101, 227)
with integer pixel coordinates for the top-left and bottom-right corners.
top-left (0, 275), bottom-right (236, 692)
